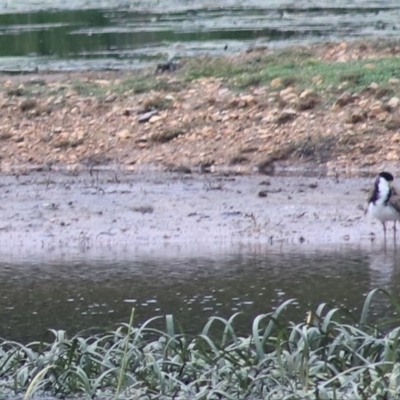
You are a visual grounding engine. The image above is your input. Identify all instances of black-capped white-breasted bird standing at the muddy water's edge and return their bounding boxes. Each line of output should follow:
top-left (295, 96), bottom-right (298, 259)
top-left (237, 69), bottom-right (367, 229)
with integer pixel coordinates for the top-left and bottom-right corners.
top-left (365, 172), bottom-right (400, 237)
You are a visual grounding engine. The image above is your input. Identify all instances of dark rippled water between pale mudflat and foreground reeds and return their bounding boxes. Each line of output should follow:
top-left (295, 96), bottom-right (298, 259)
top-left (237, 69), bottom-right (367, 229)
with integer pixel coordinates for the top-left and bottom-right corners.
top-left (0, 247), bottom-right (400, 341)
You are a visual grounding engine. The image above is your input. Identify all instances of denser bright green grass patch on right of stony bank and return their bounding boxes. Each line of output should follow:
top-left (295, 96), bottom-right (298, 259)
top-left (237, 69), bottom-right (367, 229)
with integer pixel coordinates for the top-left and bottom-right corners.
top-left (182, 50), bottom-right (400, 91)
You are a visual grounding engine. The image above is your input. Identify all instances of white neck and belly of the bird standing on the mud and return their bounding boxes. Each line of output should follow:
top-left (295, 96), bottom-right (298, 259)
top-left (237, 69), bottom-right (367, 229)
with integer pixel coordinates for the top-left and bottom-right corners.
top-left (368, 177), bottom-right (400, 228)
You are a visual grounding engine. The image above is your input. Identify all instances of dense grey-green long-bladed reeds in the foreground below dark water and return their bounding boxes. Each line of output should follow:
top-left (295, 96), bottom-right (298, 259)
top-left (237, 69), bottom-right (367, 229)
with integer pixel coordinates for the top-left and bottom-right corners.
top-left (0, 289), bottom-right (400, 400)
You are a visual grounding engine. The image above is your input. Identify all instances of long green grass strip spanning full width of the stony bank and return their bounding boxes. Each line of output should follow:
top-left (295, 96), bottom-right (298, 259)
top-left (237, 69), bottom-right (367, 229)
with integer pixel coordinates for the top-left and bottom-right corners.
top-left (4, 48), bottom-right (400, 98)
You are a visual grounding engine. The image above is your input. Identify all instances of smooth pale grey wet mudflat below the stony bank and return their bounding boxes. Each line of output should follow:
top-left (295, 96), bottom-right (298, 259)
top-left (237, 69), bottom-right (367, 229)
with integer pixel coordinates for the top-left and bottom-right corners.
top-left (0, 171), bottom-right (383, 257)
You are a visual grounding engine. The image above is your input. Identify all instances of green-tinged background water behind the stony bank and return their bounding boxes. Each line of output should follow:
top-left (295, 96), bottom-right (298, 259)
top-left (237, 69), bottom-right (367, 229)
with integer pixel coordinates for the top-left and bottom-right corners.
top-left (0, 0), bottom-right (400, 71)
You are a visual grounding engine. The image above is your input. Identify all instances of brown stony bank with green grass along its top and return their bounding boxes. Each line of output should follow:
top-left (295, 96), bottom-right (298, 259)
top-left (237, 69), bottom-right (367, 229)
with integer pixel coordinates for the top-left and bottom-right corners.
top-left (0, 40), bottom-right (400, 175)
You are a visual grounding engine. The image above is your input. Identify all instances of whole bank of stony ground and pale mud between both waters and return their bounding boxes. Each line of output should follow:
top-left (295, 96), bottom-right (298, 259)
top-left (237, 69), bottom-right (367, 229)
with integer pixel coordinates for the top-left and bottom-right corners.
top-left (0, 41), bottom-right (400, 252)
